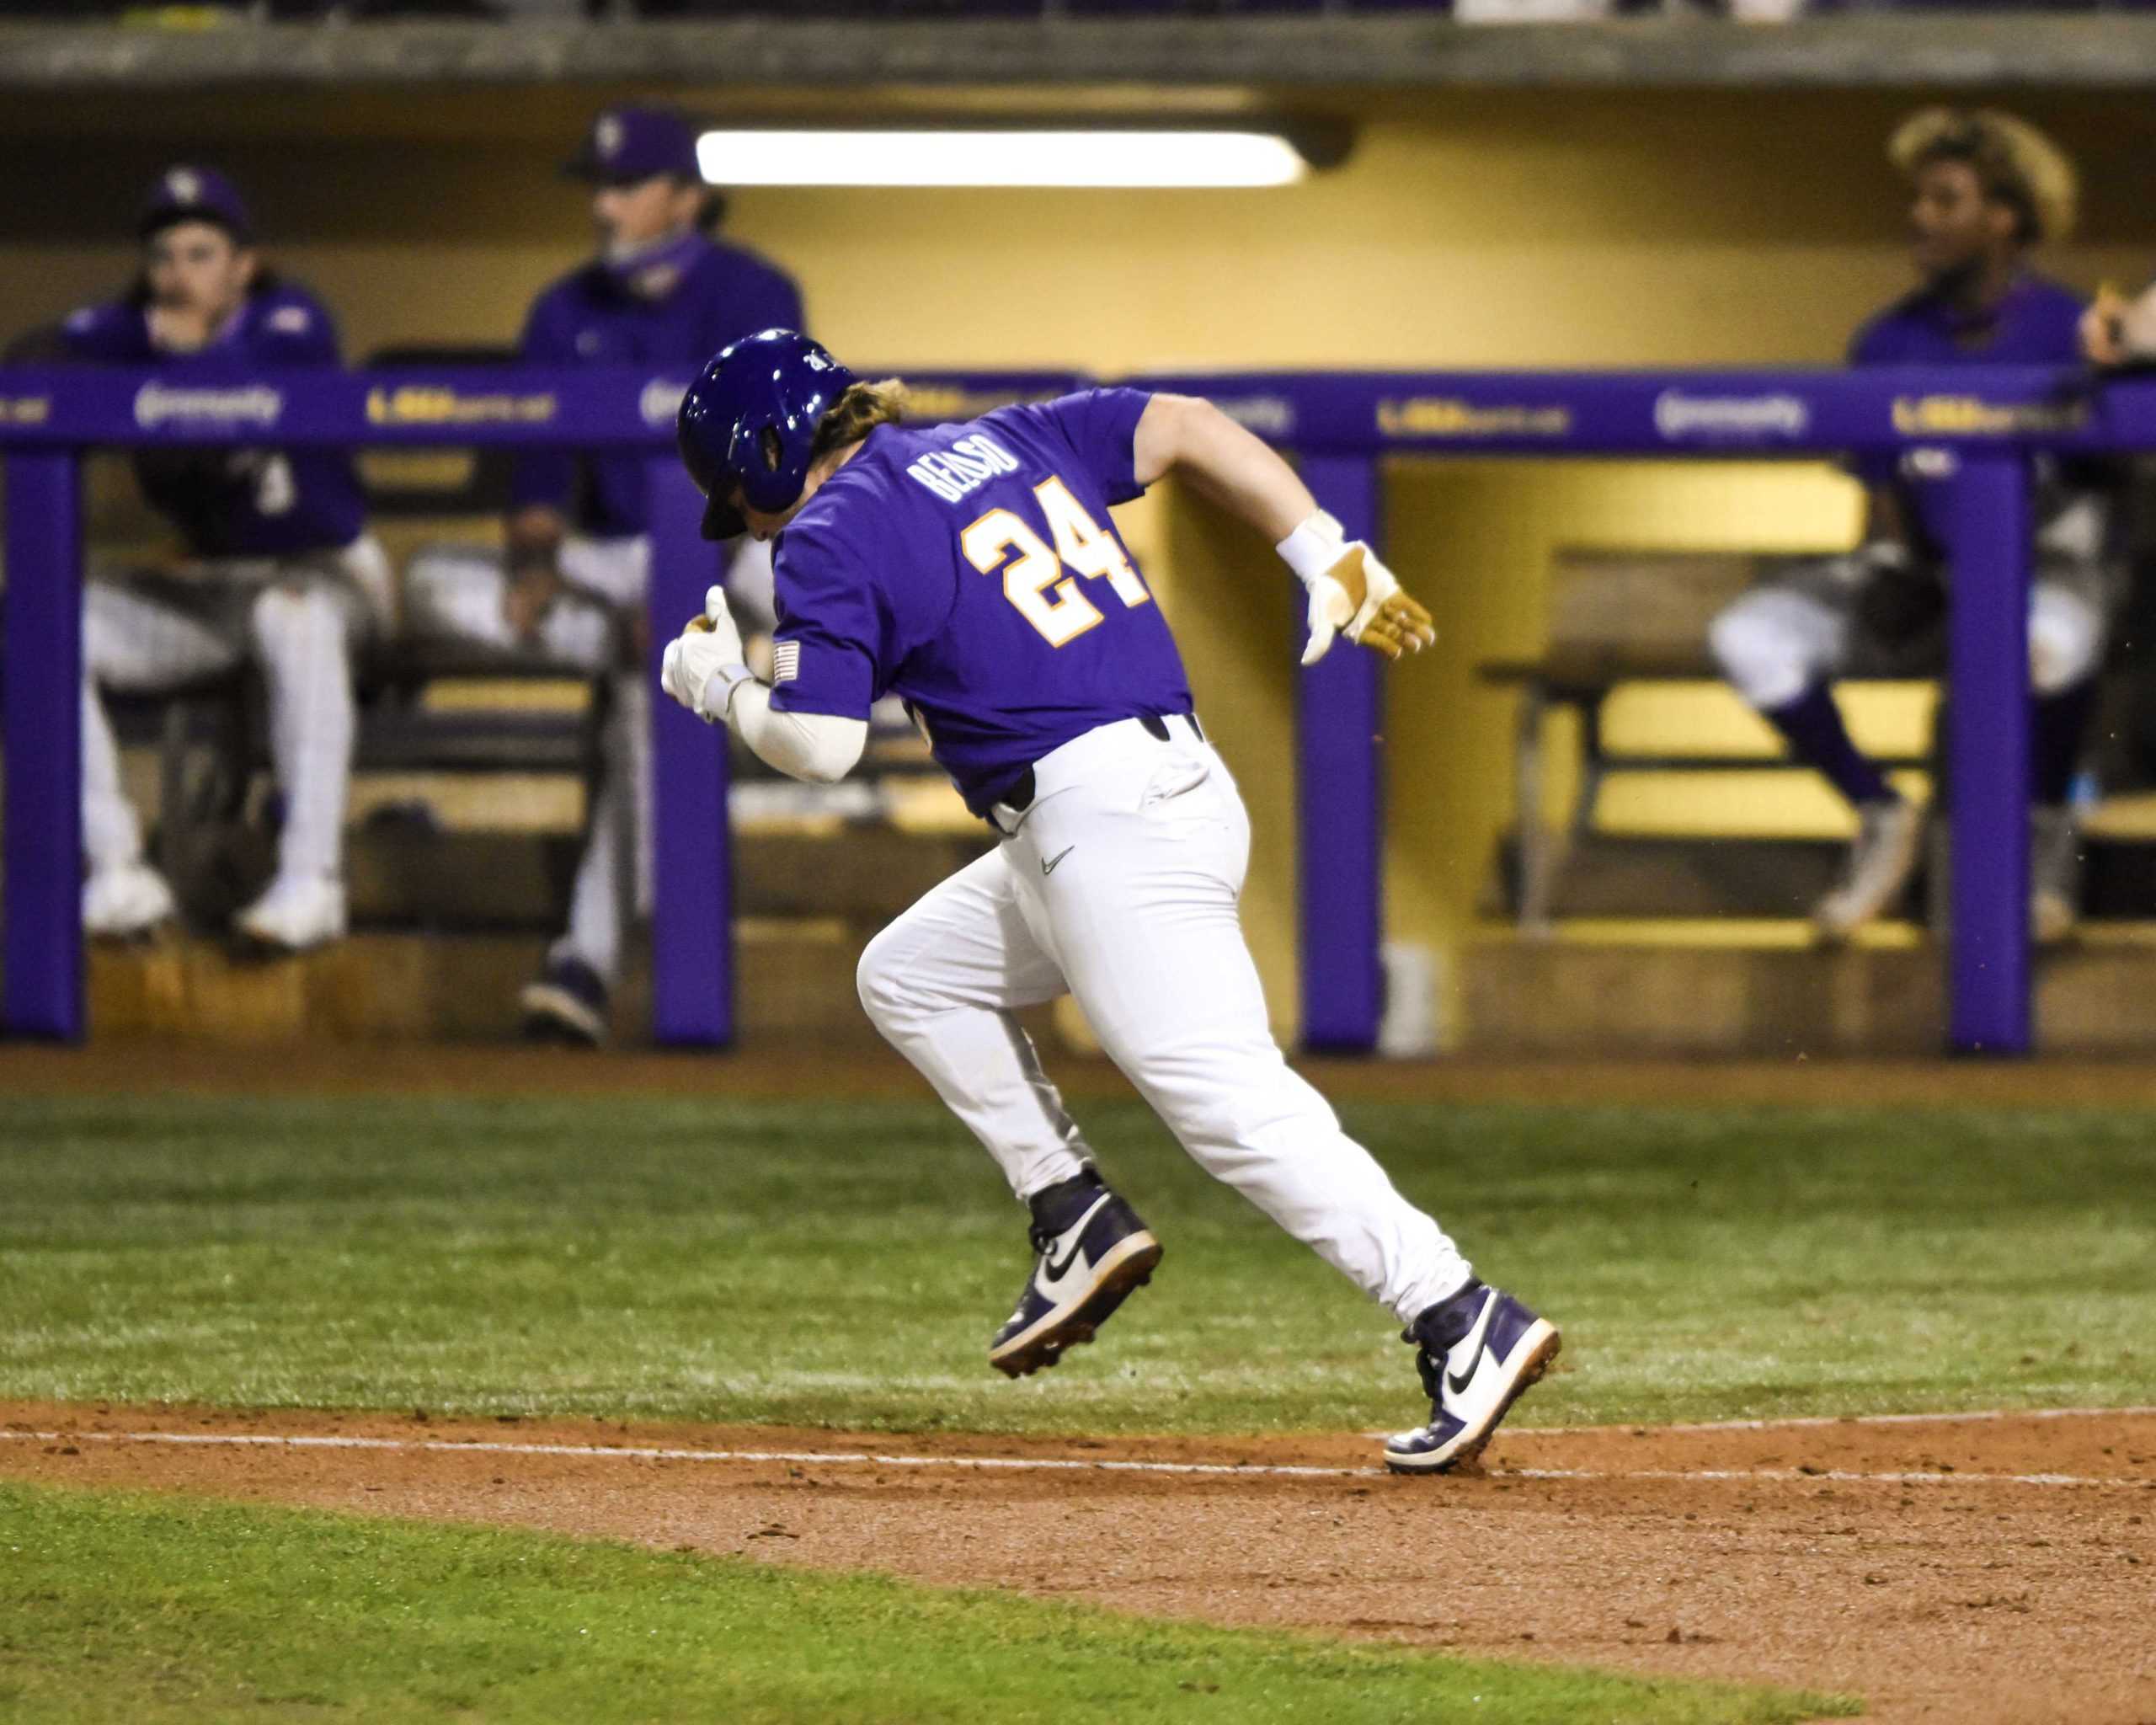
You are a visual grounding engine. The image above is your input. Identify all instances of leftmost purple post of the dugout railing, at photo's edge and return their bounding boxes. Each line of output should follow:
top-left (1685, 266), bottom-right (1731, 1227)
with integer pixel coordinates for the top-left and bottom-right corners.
top-left (0, 451), bottom-right (82, 1041)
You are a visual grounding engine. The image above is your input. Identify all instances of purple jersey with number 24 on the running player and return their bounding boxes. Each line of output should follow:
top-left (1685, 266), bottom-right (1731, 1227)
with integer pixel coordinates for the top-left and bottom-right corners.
top-left (771, 390), bottom-right (1190, 815)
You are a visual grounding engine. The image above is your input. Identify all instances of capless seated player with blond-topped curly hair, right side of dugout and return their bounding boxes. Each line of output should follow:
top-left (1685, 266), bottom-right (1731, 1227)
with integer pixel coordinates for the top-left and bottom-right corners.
top-left (1710, 108), bottom-right (2117, 940)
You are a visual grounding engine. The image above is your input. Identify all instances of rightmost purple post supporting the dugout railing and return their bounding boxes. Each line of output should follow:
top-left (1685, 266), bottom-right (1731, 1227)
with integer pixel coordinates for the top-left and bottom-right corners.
top-left (1947, 453), bottom-right (2031, 1055)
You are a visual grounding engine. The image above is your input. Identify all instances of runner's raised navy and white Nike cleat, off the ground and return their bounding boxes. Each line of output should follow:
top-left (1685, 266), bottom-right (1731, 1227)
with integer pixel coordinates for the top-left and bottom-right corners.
top-left (987, 1169), bottom-right (1160, 1378)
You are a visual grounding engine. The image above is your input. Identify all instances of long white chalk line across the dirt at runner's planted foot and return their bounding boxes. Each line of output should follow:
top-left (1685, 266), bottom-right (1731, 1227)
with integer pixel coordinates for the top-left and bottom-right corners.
top-left (0, 1432), bottom-right (2156, 1490)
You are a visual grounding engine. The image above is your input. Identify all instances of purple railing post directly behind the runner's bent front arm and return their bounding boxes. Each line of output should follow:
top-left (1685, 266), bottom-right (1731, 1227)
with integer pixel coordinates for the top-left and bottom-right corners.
top-left (644, 453), bottom-right (733, 1048)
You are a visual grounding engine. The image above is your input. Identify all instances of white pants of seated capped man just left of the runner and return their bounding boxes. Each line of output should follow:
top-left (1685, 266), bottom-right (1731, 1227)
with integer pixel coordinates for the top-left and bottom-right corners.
top-left (405, 537), bottom-right (771, 987)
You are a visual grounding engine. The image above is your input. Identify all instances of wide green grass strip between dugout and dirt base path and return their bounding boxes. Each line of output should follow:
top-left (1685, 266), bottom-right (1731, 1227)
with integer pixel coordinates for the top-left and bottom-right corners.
top-left (0, 1097), bottom-right (2156, 1432)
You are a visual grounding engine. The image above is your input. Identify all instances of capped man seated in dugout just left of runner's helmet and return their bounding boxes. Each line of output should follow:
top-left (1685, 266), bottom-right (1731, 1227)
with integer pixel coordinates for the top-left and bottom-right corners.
top-left (405, 108), bottom-right (802, 1044)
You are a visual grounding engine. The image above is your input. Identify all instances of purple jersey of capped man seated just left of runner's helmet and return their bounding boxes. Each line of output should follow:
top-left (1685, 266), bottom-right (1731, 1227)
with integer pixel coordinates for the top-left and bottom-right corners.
top-left (509, 235), bottom-right (802, 539)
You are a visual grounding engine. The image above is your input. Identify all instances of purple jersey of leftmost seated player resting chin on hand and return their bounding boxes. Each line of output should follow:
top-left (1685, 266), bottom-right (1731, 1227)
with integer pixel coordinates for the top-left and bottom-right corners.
top-left (61, 282), bottom-right (366, 556)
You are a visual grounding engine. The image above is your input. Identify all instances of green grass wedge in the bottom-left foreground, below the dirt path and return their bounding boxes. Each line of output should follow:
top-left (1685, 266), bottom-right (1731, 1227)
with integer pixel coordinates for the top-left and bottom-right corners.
top-left (0, 1483), bottom-right (1849, 1725)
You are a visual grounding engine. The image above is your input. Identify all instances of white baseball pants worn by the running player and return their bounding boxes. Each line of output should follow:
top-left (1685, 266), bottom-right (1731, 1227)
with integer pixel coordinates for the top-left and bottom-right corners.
top-left (858, 718), bottom-right (1472, 1324)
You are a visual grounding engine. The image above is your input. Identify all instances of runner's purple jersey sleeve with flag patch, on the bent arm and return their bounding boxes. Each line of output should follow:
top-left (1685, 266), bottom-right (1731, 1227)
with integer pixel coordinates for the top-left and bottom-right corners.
top-left (771, 526), bottom-right (890, 718)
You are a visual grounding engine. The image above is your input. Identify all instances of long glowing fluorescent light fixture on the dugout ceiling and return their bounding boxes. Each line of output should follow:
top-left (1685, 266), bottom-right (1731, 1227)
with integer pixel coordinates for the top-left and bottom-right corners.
top-left (696, 131), bottom-right (1309, 188)
